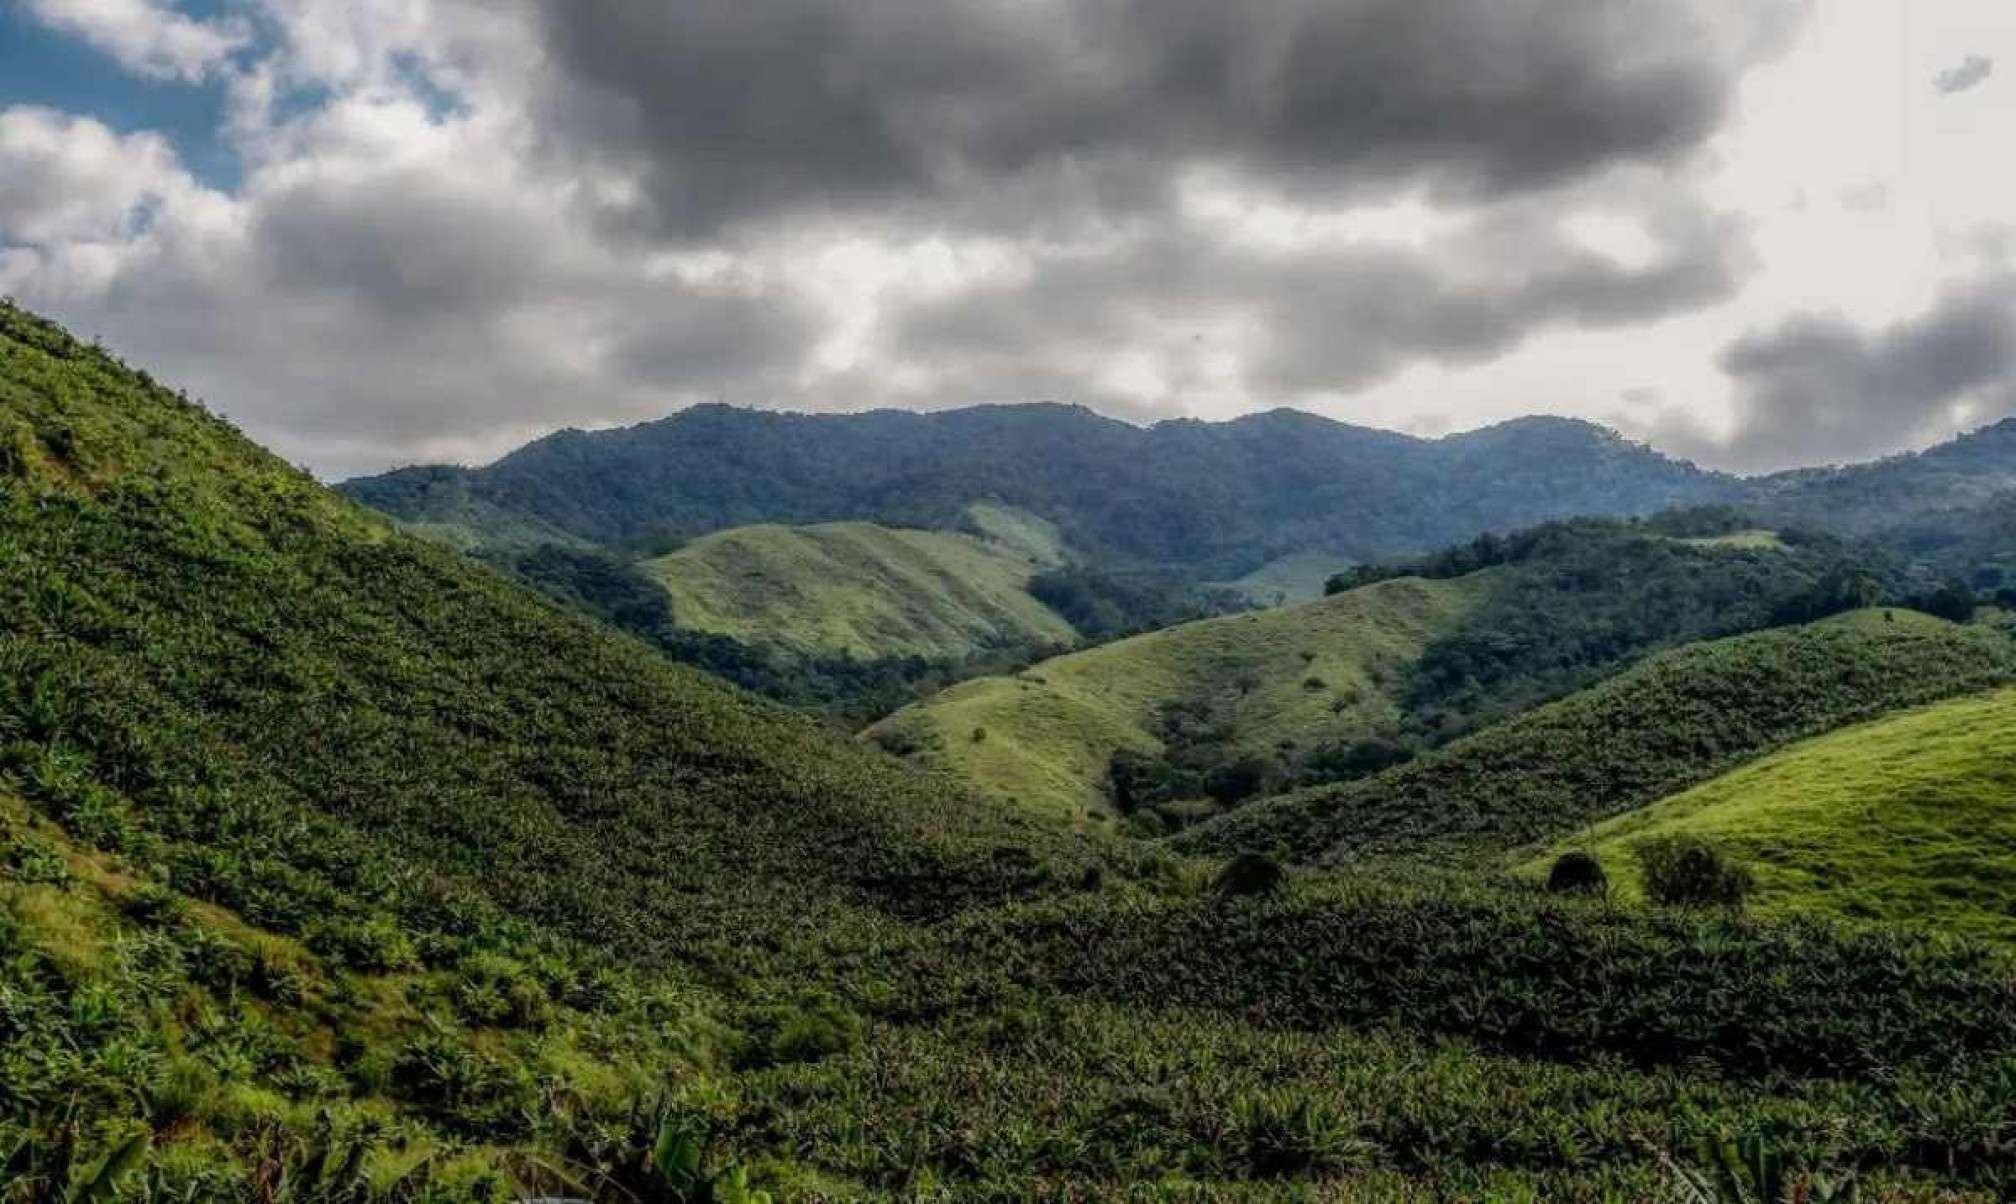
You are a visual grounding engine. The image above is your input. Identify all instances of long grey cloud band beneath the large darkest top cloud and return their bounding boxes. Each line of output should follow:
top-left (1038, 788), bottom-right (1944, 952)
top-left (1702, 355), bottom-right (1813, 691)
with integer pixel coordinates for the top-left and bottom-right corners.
top-left (897, 199), bottom-right (1744, 397)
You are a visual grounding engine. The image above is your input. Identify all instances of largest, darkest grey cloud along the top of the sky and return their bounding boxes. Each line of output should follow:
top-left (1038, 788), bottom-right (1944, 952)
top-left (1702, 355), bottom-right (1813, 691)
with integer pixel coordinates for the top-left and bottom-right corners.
top-left (536, 0), bottom-right (1796, 238)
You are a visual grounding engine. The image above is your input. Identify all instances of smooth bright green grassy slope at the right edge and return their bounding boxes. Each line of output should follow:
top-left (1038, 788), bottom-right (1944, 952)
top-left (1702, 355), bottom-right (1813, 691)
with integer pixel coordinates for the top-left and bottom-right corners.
top-left (1540, 690), bottom-right (2016, 942)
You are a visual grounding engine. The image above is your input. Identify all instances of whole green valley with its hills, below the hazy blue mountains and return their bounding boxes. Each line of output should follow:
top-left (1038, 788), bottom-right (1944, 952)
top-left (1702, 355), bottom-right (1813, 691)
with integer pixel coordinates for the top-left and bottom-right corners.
top-left (0, 298), bottom-right (2016, 1202)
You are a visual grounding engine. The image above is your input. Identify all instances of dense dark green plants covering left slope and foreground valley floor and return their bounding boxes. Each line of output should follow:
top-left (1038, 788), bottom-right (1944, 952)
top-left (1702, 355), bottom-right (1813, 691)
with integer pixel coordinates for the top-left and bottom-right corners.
top-left (0, 309), bottom-right (2016, 1202)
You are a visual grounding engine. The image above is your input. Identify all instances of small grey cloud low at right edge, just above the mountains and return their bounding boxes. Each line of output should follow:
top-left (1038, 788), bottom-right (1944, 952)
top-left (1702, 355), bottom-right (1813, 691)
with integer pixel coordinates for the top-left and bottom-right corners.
top-left (1655, 274), bottom-right (2016, 470)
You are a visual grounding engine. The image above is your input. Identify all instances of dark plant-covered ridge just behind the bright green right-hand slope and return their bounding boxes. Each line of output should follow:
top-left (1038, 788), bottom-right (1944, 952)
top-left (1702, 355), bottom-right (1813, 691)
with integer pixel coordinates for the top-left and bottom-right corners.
top-left (1177, 611), bottom-right (2016, 861)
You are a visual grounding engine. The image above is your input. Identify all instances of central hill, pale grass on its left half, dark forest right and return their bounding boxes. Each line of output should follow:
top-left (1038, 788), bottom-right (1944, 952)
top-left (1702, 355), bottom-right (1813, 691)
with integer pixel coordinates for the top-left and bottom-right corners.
top-left (869, 512), bottom-right (1907, 835)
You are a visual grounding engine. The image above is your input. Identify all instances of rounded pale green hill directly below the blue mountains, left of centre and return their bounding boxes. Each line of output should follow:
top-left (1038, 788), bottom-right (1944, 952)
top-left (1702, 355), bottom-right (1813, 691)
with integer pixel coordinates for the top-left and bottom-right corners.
top-left (639, 514), bottom-right (1077, 659)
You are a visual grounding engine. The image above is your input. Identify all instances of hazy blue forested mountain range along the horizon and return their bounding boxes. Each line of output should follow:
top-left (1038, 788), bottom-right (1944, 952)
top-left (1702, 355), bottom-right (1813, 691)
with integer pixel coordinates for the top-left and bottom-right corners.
top-left (343, 405), bottom-right (1734, 579)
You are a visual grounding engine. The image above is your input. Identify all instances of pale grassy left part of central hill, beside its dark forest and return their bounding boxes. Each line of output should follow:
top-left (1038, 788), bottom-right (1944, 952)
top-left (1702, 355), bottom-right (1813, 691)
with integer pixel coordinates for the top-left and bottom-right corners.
top-left (869, 577), bottom-right (1486, 819)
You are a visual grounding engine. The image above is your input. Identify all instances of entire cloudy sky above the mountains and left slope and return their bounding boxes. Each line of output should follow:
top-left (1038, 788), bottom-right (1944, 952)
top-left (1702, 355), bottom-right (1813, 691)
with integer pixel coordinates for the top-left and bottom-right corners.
top-left (0, 0), bottom-right (2016, 478)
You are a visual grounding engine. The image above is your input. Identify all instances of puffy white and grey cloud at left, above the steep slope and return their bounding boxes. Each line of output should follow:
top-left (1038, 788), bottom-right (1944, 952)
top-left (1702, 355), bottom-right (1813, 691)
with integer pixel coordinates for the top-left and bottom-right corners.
top-left (0, 101), bottom-right (810, 474)
